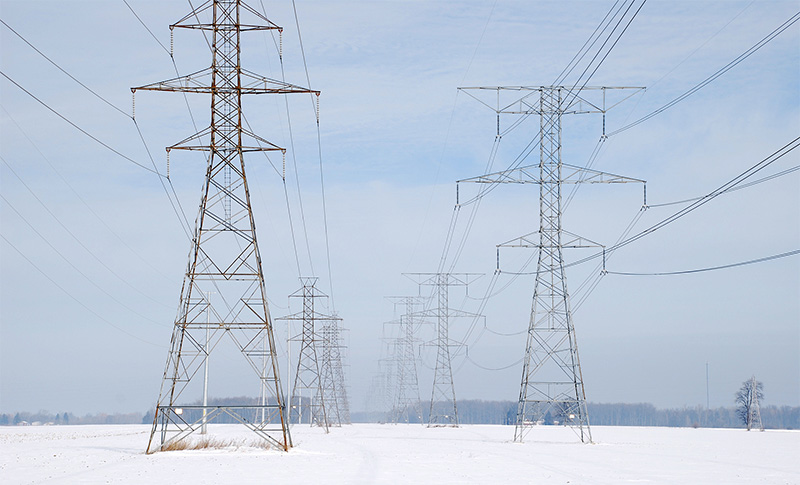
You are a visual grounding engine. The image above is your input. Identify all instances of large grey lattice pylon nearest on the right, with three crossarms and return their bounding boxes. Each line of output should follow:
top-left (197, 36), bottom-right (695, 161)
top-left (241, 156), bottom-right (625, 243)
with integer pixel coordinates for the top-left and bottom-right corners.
top-left (458, 86), bottom-right (644, 442)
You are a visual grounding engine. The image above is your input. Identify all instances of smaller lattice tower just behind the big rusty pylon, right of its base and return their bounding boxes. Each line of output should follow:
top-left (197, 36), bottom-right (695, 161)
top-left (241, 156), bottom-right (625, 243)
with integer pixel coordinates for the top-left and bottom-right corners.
top-left (278, 277), bottom-right (341, 432)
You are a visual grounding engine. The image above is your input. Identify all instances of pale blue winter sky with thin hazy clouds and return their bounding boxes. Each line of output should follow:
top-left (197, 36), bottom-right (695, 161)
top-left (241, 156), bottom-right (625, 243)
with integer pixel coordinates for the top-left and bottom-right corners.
top-left (0, 0), bottom-right (800, 413)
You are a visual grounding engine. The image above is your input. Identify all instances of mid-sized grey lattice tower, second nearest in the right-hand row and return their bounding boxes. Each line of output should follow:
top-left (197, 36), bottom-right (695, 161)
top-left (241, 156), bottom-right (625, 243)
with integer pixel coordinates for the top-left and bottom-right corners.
top-left (405, 273), bottom-right (482, 428)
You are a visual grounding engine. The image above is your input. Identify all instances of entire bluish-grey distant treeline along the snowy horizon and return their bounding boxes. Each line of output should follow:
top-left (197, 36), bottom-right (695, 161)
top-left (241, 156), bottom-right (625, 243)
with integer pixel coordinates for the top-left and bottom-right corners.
top-left (0, 398), bottom-right (800, 429)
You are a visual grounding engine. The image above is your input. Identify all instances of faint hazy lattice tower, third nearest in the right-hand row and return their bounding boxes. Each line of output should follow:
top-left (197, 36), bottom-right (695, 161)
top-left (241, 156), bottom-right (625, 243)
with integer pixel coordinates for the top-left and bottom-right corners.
top-left (389, 296), bottom-right (422, 424)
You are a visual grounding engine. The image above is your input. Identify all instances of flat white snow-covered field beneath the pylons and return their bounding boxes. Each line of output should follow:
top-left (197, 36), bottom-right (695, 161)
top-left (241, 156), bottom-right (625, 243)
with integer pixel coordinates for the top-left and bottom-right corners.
top-left (0, 424), bottom-right (800, 484)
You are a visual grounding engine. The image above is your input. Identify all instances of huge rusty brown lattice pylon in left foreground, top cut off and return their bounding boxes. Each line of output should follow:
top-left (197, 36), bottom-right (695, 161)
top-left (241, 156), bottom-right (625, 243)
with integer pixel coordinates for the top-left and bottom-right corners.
top-left (132, 0), bottom-right (319, 453)
